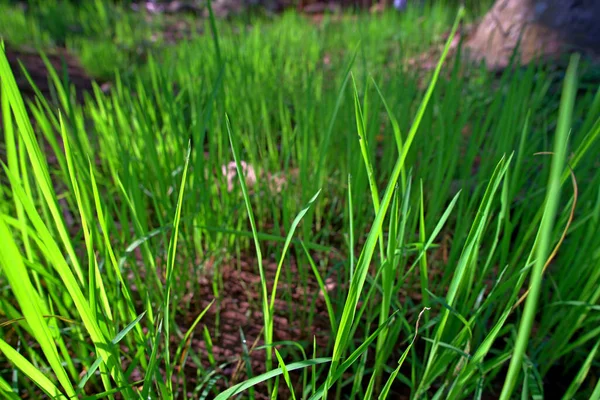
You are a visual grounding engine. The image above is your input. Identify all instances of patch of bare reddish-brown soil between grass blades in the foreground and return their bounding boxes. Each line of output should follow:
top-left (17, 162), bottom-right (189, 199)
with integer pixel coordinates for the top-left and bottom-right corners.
top-left (181, 257), bottom-right (335, 398)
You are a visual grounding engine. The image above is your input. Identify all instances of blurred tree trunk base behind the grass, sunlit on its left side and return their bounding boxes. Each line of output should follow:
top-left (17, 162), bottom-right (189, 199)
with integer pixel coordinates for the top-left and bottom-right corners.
top-left (466, 0), bottom-right (600, 69)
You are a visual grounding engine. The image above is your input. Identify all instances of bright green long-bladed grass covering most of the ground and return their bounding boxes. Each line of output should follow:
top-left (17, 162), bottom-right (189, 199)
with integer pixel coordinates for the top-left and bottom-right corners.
top-left (0, 2), bottom-right (600, 399)
